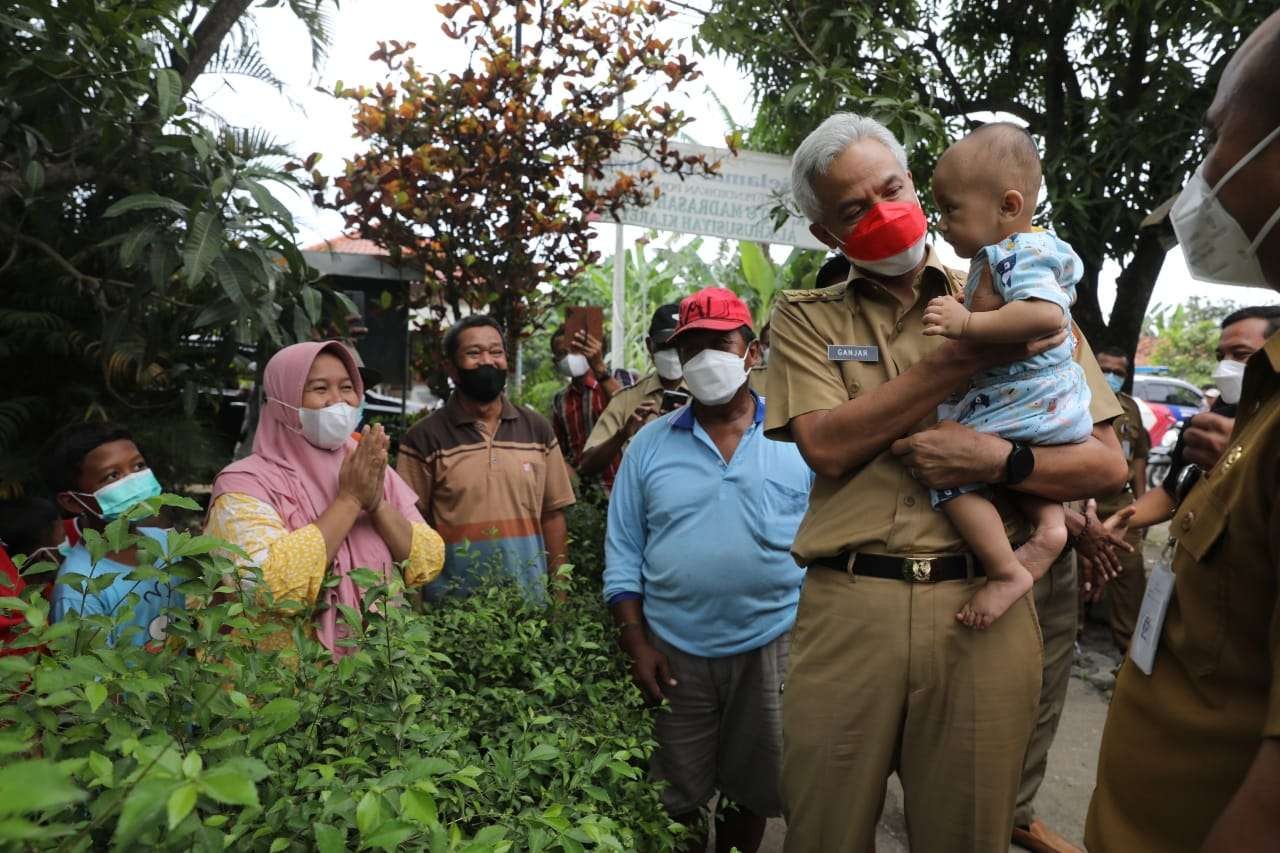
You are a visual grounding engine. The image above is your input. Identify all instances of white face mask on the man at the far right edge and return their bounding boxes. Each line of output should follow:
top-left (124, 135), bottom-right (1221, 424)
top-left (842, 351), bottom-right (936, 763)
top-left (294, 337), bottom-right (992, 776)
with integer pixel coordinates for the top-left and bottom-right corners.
top-left (1169, 127), bottom-right (1280, 286)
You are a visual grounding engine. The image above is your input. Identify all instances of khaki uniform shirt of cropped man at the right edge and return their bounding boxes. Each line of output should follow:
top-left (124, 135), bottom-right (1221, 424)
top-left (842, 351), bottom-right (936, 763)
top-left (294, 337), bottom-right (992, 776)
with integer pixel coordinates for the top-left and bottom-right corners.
top-left (1085, 334), bottom-right (1280, 850)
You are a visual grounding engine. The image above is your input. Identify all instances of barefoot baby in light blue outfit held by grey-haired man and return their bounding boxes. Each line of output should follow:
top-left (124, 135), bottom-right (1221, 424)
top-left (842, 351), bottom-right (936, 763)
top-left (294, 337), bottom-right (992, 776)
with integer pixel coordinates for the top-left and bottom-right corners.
top-left (924, 122), bottom-right (1093, 629)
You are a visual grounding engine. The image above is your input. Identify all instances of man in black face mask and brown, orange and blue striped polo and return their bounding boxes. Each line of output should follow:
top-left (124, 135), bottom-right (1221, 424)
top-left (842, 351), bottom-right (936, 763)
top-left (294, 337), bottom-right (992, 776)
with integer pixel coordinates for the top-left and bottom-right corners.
top-left (396, 315), bottom-right (573, 597)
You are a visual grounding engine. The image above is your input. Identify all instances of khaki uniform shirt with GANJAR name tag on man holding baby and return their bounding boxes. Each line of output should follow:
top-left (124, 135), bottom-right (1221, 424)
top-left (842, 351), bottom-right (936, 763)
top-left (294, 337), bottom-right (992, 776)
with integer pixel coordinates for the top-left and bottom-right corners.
top-left (764, 247), bottom-right (1120, 565)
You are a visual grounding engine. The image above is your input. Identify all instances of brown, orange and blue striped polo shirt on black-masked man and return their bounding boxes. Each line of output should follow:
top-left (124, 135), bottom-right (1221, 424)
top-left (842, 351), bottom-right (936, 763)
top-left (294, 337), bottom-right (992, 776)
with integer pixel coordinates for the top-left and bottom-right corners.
top-left (396, 396), bottom-right (573, 588)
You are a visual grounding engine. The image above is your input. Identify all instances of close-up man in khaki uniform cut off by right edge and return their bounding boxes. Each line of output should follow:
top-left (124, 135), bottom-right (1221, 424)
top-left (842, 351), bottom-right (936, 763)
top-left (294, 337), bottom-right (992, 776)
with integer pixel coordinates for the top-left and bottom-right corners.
top-left (1085, 13), bottom-right (1280, 853)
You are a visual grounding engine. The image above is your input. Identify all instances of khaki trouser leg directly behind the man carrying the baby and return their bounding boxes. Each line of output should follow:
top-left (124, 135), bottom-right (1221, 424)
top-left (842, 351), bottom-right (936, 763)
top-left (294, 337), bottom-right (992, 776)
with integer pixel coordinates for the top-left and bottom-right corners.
top-left (1014, 548), bottom-right (1079, 826)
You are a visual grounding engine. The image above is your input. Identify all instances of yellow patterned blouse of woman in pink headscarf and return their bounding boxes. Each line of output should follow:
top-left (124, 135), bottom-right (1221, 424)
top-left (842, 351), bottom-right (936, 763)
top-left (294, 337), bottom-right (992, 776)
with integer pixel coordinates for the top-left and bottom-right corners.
top-left (205, 492), bottom-right (444, 603)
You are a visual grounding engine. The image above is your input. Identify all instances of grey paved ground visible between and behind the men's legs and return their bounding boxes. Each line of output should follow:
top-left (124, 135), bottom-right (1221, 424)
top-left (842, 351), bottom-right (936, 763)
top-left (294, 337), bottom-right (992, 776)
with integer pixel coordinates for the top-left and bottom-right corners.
top-left (737, 528), bottom-right (1167, 853)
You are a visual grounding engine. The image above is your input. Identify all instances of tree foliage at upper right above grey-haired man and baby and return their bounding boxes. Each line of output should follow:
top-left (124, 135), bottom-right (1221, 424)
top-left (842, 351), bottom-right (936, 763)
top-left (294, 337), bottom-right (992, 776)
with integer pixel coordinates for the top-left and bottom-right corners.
top-left (699, 0), bottom-right (1277, 350)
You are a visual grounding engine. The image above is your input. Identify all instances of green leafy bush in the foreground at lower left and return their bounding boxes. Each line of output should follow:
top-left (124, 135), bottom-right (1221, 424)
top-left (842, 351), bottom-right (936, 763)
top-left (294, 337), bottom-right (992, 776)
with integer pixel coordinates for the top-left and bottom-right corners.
top-left (0, 496), bottom-right (684, 853)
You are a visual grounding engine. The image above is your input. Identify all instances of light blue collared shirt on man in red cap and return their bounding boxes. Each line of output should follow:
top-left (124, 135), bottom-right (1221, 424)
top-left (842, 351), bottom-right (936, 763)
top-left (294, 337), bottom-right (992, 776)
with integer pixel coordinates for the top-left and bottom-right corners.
top-left (604, 397), bottom-right (813, 657)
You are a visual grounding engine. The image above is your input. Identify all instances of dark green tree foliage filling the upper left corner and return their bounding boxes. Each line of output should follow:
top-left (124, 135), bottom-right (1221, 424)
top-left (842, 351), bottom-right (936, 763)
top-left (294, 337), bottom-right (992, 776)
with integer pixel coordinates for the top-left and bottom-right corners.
top-left (0, 0), bottom-right (345, 488)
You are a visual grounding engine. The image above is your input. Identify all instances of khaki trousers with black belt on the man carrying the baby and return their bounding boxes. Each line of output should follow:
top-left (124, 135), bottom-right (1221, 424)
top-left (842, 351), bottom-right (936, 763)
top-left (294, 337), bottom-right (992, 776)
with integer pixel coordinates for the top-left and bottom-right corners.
top-left (782, 569), bottom-right (1042, 853)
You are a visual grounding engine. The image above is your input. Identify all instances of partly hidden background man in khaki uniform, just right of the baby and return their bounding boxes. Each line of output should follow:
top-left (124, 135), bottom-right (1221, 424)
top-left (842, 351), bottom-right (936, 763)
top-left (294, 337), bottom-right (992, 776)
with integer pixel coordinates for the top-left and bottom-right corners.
top-left (1098, 348), bottom-right (1151, 652)
